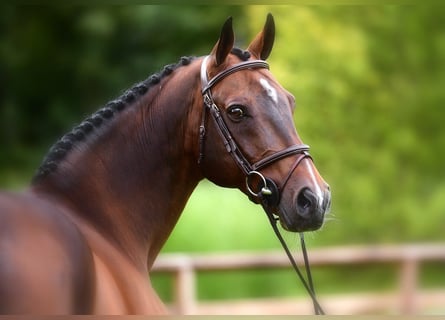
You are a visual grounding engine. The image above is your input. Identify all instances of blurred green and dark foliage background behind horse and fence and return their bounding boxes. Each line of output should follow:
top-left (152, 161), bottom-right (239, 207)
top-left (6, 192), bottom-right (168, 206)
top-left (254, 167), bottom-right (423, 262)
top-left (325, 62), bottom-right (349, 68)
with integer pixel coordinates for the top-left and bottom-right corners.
top-left (0, 5), bottom-right (445, 313)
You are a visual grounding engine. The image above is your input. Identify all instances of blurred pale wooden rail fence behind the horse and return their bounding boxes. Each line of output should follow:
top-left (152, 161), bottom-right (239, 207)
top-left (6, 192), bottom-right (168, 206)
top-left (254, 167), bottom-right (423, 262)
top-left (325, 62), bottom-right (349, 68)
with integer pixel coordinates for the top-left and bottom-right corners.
top-left (151, 244), bottom-right (445, 315)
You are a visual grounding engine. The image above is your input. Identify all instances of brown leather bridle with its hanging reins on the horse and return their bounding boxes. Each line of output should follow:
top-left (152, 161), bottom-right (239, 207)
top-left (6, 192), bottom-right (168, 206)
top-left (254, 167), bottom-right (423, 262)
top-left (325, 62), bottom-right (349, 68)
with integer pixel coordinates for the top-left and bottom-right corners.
top-left (198, 56), bottom-right (324, 314)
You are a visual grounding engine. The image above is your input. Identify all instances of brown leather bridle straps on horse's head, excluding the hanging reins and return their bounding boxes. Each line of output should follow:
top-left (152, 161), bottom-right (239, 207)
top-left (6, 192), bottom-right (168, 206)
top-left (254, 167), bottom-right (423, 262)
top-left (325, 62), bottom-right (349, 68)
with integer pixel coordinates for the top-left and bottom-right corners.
top-left (198, 56), bottom-right (312, 208)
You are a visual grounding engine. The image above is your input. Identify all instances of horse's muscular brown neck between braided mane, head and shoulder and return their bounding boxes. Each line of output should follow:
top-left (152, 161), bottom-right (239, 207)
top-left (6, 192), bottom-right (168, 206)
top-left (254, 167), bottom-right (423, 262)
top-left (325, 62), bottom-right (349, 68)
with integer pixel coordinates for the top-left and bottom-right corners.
top-left (35, 60), bottom-right (201, 270)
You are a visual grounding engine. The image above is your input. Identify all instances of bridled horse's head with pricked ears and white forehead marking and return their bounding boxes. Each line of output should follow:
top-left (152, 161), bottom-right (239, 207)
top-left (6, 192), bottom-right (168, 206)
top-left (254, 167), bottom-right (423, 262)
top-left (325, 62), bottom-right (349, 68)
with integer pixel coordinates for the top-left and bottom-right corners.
top-left (200, 15), bottom-right (330, 232)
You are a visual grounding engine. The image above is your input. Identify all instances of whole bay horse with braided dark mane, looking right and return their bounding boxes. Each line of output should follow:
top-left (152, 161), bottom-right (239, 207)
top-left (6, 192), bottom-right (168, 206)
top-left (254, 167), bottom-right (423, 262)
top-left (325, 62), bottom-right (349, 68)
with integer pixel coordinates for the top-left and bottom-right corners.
top-left (0, 15), bottom-right (330, 314)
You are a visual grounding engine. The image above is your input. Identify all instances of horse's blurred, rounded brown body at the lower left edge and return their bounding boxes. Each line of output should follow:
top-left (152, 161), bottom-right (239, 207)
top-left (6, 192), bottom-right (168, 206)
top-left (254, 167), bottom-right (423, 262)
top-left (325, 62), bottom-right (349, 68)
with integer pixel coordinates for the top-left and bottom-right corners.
top-left (0, 192), bottom-right (94, 313)
